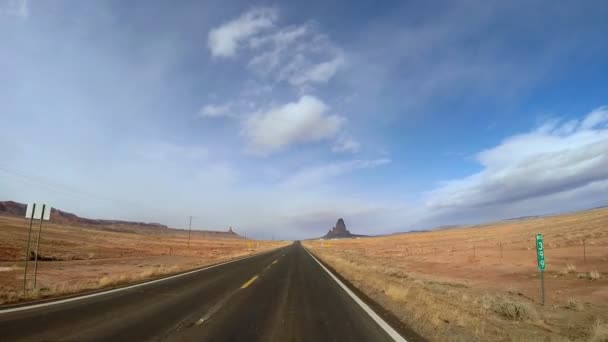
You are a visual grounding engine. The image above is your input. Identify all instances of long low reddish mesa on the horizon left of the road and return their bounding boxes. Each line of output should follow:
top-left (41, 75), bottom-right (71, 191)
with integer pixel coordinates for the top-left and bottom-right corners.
top-left (0, 201), bottom-right (243, 239)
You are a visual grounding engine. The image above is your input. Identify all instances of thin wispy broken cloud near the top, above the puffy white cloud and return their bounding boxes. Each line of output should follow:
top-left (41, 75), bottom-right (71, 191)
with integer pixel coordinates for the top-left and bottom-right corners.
top-left (209, 9), bottom-right (344, 88)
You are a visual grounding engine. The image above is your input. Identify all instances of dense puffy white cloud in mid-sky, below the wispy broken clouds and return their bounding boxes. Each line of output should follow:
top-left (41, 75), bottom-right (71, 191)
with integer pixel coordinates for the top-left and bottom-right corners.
top-left (243, 95), bottom-right (345, 154)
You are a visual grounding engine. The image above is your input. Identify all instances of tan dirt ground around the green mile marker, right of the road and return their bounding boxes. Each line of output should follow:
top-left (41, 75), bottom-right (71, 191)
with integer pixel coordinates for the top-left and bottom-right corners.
top-left (304, 209), bottom-right (608, 341)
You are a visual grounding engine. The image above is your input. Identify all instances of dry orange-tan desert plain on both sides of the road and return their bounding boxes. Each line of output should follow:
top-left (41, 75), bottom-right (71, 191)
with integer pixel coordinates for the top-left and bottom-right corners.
top-left (0, 208), bottom-right (608, 342)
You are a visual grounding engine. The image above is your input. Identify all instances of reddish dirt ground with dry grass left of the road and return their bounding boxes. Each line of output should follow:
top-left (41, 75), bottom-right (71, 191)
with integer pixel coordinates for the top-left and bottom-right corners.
top-left (0, 216), bottom-right (288, 304)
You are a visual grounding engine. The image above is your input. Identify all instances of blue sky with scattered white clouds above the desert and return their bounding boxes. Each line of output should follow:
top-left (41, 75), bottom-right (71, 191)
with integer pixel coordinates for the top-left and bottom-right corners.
top-left (0, 0), bottom-right (608, 239)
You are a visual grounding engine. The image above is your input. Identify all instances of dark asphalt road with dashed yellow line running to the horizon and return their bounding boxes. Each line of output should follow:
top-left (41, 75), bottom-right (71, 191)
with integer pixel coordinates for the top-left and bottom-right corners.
top-left (0, 243), bottom-right (419, 341)
